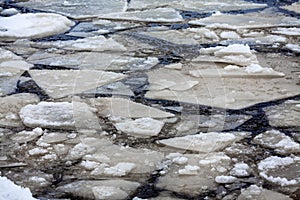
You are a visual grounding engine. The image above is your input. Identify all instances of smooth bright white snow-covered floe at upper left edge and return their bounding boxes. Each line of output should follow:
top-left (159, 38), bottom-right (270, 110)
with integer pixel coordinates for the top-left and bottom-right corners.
top-left (0, 13), bottom-right (75, 40)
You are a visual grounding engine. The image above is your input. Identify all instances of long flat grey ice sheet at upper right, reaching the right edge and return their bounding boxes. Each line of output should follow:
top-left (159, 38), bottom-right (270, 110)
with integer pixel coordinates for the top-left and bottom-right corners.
top-left (189, 13), bottom-right (300, 29)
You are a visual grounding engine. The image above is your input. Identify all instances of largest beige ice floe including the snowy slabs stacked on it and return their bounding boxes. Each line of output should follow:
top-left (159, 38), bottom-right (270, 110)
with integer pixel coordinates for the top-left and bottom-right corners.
top-left (146, 44), bottom-right (299, 109)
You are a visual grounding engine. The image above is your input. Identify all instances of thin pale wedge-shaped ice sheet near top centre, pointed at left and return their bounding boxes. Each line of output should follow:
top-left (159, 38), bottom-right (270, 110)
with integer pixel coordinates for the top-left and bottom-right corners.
top-left (99, 8), bottom-right (183, 22)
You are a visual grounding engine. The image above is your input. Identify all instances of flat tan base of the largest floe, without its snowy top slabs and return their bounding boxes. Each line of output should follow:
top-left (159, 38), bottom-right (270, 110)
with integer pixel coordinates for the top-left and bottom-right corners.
top-left (145, 63), bottom-right (299, 109)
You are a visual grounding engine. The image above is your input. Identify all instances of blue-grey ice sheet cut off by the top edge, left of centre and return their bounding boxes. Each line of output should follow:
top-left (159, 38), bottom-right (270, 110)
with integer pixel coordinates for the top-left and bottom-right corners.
top-left (18, 0), bottom-right (126, 19)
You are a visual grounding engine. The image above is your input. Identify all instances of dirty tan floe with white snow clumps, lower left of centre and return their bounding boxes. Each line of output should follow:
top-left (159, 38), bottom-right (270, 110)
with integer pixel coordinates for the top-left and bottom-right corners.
top-left (65, 137), bottom-right (163, 178)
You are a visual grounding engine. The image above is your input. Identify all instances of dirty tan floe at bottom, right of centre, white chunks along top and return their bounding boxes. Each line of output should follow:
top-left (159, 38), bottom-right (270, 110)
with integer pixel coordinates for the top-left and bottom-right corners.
top-left (156, 153), bottom-right (231, 196)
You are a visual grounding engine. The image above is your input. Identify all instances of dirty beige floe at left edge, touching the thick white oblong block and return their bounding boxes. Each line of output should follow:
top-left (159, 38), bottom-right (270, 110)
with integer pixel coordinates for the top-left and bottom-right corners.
top-left (0, 93), bottom-right (39, 127)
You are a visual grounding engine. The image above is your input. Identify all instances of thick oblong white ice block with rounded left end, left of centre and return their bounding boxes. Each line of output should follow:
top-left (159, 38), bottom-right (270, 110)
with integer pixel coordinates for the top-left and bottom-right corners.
top-left (20, 101), bottom-right (101, 130)
